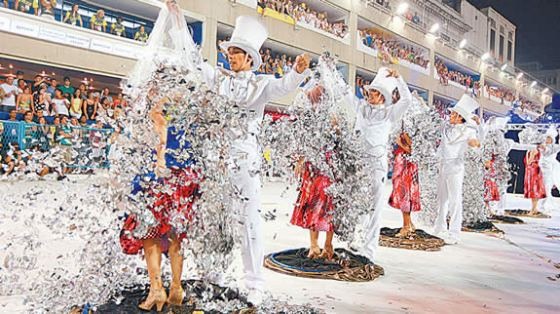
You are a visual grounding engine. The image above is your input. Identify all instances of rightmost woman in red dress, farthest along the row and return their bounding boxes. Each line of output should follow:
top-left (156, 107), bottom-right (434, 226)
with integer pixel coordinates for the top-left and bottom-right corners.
top-left (523, 149), bottom-right (546, 215)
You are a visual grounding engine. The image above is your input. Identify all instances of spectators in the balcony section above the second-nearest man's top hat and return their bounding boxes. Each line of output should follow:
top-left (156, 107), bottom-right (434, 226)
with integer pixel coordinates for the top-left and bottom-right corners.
top-left (360, 29), bottom-right (430, 69)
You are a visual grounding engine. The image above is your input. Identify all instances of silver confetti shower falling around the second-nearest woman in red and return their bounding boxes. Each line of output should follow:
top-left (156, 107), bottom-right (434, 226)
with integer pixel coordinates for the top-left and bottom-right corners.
top-left (262, 53), bottom-right (372, 241)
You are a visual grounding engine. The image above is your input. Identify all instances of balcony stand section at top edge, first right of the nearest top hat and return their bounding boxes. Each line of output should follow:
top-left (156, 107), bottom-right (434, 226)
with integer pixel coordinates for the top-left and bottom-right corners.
top-left (257, 0), bottom-right (351, 45)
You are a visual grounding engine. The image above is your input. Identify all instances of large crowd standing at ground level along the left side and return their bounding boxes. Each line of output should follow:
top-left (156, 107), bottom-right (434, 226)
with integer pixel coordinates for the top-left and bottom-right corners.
top-left (0, 71), bottom-right (122, 175)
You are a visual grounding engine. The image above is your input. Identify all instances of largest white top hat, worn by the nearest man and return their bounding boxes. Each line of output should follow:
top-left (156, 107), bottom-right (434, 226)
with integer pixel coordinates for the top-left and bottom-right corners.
top-left (220, 16), bottom-right (268, 71)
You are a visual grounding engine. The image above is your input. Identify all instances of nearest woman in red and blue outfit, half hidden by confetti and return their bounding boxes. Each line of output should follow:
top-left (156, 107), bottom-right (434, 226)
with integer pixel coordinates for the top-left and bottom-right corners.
top-left (120, 99), bottom-right (199, 311)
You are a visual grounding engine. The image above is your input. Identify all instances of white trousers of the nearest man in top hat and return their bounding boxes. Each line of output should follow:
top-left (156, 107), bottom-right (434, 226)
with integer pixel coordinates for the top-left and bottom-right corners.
top-left (230, 141), bottom-right (264, 290)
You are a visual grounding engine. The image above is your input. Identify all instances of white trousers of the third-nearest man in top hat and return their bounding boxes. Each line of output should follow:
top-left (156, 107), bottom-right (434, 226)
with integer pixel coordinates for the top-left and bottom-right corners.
top-left (434, 168), bottom-right (465, 237)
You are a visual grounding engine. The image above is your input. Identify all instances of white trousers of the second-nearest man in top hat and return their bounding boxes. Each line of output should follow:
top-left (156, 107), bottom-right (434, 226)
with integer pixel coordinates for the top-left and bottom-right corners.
top-left (360, 170), bottom-right (387, 262)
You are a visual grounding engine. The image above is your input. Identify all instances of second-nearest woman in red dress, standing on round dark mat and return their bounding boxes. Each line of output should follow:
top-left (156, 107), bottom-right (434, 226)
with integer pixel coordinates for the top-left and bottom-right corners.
top-left (290, 156), bottom-right (334, 260)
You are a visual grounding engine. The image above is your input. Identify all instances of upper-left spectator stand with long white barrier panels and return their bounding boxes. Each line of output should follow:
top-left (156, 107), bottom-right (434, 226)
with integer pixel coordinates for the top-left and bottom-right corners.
top-left (0, 0), bottom-right (204, 58)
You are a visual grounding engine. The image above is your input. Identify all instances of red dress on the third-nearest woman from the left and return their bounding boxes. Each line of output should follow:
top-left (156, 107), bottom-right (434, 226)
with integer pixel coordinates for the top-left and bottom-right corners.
top-left (389, 146), bottom-right (421, 213)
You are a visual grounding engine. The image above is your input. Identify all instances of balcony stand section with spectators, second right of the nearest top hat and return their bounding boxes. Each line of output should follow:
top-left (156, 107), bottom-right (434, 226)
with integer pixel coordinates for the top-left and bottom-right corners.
top-left (356, 18), bottom-right (430, 75)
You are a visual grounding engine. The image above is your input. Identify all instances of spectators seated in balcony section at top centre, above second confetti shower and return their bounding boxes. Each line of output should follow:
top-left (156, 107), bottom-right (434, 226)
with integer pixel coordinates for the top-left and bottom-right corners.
top-left (257, 0), bottom-right (348, 38)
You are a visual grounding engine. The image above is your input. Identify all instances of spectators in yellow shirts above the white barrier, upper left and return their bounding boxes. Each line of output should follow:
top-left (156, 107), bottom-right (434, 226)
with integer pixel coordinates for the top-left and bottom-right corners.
top-left (0, 0), bottom-right (149, 42)
